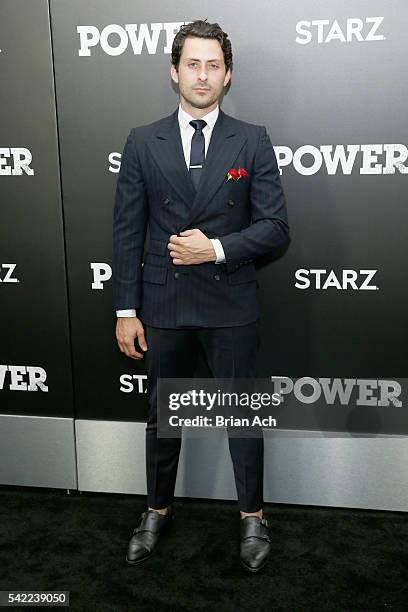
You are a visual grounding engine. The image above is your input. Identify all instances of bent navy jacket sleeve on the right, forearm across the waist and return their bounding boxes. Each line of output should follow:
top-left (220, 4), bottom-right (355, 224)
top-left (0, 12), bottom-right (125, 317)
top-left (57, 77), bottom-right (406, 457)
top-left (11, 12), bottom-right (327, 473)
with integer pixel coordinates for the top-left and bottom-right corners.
top-left (218, 126), bottom-right (289, 262)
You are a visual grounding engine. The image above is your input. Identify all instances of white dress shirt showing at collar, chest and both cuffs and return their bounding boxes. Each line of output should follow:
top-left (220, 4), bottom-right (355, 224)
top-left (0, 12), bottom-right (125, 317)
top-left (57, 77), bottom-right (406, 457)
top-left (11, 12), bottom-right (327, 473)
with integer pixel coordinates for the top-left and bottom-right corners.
top-left (116, 104), bottom-right (225, 317)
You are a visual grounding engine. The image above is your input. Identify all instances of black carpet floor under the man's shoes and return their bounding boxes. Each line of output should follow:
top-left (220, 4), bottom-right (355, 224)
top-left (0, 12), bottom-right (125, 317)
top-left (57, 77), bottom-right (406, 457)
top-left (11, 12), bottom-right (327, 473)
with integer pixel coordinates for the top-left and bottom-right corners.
top-left (0, 486), bottom-right (408, 612)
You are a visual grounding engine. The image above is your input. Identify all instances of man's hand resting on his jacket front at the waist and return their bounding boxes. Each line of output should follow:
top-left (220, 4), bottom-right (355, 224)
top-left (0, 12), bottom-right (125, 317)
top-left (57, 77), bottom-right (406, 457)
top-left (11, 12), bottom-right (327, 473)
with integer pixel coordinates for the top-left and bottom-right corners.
top-left (167, 229), bottom-right (217, 266)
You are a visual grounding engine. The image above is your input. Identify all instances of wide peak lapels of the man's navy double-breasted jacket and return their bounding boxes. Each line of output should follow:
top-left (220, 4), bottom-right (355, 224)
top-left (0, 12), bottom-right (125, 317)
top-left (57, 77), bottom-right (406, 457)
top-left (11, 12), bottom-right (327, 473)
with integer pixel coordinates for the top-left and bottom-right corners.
top-left (148, 108), bottom-right (247, 227)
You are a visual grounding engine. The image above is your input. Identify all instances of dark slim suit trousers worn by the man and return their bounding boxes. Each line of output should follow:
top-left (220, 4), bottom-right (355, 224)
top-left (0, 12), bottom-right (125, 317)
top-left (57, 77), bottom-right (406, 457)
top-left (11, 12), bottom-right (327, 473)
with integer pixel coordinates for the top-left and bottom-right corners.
top-left (145, 321), bottom-right (264, 512)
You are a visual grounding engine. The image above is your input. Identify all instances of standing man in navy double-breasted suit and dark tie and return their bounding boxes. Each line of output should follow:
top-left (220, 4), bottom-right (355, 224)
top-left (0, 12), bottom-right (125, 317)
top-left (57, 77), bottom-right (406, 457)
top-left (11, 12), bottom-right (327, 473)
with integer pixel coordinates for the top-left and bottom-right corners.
top-left (113, 20), bottom-right (288, 572)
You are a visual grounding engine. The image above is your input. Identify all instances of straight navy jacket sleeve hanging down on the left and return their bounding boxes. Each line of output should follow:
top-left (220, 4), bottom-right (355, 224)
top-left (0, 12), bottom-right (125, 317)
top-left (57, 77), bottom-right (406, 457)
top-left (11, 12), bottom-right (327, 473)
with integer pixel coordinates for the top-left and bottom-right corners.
top-left (112, 128), bottom-right (148, 310)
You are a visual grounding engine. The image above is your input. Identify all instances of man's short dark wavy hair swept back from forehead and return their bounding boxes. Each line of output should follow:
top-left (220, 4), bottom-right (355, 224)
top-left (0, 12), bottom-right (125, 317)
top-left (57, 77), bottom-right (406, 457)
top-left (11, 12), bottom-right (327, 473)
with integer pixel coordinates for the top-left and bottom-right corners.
top-left (171, 19), bottom-right (232, 71)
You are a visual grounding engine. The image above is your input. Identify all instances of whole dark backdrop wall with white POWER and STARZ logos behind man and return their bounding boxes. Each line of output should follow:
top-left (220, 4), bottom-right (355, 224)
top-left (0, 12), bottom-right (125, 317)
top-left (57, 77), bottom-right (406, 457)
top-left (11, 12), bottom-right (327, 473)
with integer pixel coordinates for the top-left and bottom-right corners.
top-left (0, 0), bottom-right (408, 433)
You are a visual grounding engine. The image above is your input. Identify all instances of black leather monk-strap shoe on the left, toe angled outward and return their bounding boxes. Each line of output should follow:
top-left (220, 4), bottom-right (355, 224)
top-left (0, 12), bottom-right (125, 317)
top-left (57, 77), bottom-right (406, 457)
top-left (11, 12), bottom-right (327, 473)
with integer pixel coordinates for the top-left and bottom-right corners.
top-left (126, 508), bottom-right (173, 565)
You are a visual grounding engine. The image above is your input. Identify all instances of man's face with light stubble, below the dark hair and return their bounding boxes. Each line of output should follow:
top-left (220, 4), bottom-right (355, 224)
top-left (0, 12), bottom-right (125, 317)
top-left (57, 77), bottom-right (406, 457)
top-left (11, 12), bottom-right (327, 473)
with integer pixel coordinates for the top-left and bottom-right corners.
top-left (171, 37), bottom-right (231, 109)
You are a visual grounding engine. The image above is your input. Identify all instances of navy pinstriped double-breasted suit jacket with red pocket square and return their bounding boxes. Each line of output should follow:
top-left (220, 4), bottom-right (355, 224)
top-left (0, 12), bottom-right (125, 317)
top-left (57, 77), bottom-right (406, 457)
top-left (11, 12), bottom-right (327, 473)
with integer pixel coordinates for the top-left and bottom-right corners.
top-left (112, 108), bottom-right (289, 328)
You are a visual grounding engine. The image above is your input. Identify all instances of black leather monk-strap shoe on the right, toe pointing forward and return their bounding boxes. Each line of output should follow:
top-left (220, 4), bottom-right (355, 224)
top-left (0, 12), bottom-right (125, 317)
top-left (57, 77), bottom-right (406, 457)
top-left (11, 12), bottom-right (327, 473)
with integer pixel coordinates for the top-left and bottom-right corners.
top-left (240, 516), bottom-right (271, 573)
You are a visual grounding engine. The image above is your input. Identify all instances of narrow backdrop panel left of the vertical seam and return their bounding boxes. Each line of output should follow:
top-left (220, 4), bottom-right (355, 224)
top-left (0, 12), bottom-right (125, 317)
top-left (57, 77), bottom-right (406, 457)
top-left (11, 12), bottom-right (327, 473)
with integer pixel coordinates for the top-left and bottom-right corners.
top-left (0, 0), bottom-right (73, 416)
